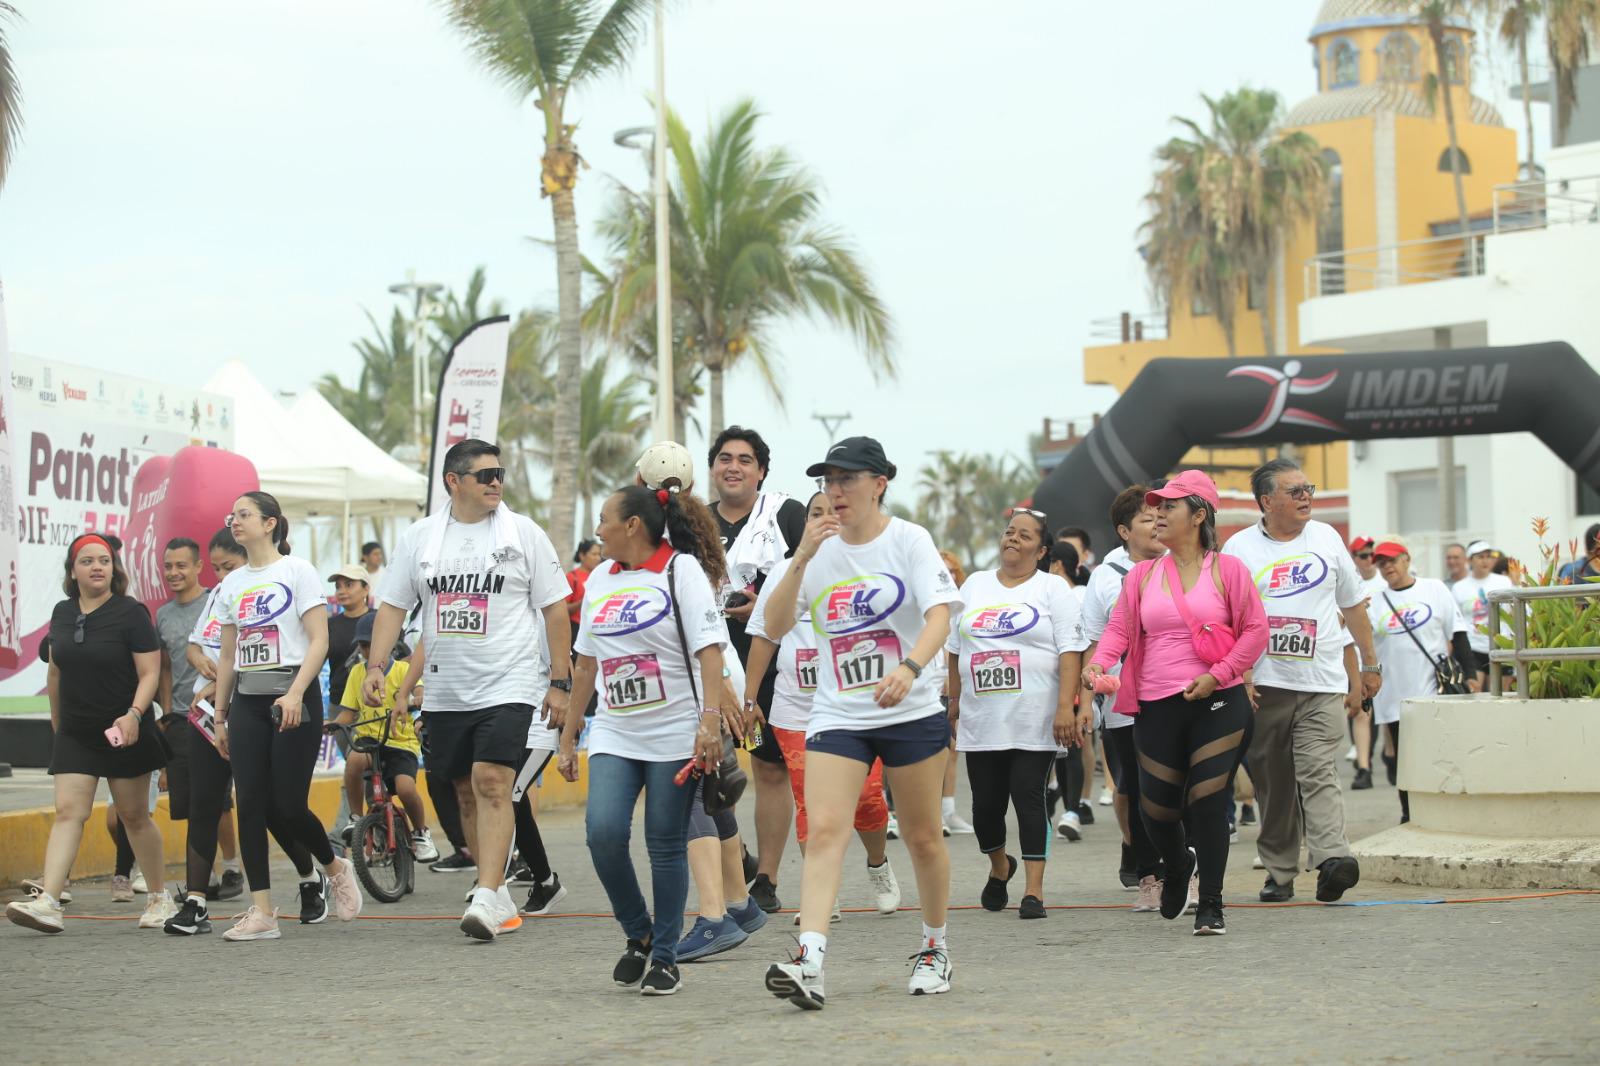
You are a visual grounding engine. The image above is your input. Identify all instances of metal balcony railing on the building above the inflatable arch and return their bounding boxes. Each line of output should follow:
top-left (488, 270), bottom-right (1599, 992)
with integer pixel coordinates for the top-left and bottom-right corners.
top-left (1306, 176), bottom-right (1600, 296)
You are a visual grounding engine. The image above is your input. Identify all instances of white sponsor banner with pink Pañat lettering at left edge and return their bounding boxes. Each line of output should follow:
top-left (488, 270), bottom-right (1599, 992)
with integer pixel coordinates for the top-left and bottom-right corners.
top-left (0, 354), bottom-right (234, 695)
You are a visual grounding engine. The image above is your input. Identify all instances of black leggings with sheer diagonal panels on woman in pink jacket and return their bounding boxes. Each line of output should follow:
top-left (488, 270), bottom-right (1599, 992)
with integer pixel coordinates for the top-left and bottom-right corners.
top-left (1133, 685), bottom-right (1254, 900)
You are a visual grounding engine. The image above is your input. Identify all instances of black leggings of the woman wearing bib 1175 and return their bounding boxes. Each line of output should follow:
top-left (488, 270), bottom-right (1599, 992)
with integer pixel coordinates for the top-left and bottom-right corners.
top-left (230, 687), bottom-right (333, 892)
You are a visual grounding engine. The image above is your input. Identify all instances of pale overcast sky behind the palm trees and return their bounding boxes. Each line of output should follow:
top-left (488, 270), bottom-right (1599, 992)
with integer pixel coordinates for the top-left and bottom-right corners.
top-left (0, 0), bottom-right (1544, 508)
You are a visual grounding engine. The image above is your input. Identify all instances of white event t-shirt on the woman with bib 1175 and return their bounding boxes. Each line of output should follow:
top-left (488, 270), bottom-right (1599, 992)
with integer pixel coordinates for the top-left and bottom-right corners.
top-left (213, 555), bottom-right (328, 671)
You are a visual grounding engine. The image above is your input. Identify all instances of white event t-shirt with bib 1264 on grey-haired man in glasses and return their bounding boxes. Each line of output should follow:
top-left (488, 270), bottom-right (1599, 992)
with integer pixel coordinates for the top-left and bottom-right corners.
top-left (1222, 519), bottom-right (1368, 693)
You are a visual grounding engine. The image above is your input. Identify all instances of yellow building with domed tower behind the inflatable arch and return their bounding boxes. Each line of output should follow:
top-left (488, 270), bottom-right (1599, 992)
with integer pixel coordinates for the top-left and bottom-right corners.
top-left (1083, 0), bottom-right (1517, 491)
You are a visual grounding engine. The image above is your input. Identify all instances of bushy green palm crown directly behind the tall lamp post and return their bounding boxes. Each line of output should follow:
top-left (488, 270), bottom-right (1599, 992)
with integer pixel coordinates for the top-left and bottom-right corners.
top-left (602, 99), bottom-right (894, 434)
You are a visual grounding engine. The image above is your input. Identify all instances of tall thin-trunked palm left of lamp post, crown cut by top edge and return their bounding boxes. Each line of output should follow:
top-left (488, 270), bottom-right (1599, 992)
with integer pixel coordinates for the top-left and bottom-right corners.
top-left (440, 0), bottom-right (651, 552)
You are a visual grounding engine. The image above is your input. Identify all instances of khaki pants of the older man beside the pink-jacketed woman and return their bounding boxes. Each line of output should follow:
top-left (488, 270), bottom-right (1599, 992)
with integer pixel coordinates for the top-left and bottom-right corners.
top-left (1250, 688), bottom-right (1350, 885)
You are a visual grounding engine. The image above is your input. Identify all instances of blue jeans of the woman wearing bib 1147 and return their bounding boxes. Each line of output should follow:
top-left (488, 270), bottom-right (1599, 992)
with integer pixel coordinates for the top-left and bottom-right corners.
top-left (584, 745), bottom-right (694, 964)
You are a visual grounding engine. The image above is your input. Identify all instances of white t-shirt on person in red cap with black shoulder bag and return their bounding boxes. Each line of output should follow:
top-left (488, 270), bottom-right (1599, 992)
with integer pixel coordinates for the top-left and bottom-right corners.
top-left (1366, 578), bottom-right (1467, 725)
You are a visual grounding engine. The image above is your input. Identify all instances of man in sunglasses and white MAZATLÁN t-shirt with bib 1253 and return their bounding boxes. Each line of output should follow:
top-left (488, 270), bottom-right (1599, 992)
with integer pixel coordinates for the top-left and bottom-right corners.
top-left (362, 439), bottom-right (571, 940)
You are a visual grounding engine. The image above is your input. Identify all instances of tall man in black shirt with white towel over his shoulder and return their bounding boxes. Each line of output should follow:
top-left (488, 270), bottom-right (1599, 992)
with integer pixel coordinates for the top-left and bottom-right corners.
top-left (706, 426), bottom-right (806, 914)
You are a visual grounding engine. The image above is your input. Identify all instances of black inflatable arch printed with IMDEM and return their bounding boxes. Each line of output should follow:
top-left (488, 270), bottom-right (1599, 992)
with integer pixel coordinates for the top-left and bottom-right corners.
top-left (1034, 341), bottom-right (1600, 552)
